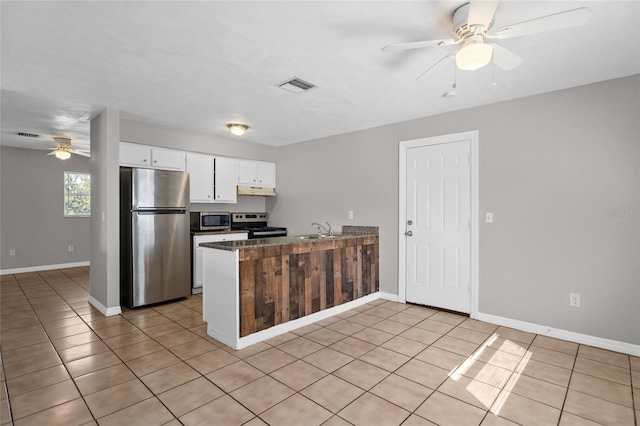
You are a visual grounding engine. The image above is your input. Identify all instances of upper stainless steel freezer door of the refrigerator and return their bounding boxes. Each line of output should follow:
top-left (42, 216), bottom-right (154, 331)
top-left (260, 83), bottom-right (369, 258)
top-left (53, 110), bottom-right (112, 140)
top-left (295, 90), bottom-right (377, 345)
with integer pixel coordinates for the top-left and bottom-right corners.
top-left (131, 169), bottom-right (189, 210)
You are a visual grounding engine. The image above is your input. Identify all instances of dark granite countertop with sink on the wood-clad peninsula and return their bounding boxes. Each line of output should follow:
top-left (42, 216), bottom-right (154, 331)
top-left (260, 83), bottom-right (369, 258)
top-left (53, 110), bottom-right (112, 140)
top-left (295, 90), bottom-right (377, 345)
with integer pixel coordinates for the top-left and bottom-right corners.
top-left (200, 226), bottom-right (378, 251)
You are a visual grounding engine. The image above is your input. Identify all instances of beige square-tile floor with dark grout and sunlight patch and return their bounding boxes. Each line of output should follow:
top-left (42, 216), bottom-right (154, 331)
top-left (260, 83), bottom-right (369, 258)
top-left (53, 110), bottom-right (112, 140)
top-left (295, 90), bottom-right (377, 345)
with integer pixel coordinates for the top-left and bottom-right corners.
top-left (0, 268), bottom-right (640, 426)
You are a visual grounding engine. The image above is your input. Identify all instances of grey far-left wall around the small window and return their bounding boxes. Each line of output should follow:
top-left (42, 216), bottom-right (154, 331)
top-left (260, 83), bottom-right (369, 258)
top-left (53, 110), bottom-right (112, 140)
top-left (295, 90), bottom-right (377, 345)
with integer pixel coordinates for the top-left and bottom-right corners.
top-left (0, 146), bottom-right (89, 271)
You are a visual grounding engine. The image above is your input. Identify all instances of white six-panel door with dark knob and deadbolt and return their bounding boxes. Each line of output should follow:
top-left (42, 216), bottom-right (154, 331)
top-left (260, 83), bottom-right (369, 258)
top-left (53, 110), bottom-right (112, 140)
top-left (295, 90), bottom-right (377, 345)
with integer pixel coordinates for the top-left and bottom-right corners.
top-left (401, 138), bottom-right (472, 313)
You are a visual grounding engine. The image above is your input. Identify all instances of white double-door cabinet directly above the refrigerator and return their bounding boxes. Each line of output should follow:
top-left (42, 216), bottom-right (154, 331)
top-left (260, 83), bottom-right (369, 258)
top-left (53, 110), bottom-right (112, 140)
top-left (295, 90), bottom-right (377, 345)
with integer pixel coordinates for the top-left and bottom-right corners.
top-left (120, 142), bottom-right (185, 171)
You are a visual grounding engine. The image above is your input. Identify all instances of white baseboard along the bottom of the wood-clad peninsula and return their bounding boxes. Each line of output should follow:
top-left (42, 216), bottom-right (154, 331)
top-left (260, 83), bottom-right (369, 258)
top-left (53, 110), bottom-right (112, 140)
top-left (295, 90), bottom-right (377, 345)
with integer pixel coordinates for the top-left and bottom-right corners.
top-left (212, 292), bottom-right (381, 350)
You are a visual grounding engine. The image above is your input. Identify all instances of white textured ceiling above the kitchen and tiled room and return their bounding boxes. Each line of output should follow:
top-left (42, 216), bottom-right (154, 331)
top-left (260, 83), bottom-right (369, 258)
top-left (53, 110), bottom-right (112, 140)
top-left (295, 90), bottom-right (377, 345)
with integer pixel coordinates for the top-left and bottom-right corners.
top-left (1, 0), bottom-right (640, 151)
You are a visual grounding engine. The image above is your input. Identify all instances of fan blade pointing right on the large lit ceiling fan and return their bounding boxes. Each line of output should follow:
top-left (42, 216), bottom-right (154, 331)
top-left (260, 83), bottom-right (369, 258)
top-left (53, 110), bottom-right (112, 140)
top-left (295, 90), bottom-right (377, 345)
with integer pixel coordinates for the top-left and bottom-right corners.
top-left (490, 7), bottom-right (591, 39)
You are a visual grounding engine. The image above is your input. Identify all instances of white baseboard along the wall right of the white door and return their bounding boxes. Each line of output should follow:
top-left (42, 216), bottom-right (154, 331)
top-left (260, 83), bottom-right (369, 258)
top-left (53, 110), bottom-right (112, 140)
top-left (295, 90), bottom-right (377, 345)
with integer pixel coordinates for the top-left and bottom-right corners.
top-left (478, 313), bottom-right (640, 356)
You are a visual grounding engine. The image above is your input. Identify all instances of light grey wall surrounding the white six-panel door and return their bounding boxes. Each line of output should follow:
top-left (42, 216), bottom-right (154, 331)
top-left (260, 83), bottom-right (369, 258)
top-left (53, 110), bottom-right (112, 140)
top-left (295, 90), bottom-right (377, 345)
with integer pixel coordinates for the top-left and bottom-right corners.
top-left (267, 75), bottom-right (640, 345)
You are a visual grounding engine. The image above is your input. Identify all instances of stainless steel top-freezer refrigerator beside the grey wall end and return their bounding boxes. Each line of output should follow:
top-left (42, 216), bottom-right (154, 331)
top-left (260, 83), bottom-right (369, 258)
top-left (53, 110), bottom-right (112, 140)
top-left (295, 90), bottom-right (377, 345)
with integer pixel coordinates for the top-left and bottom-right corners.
top-left (120, 168), bottom-right (191, 308)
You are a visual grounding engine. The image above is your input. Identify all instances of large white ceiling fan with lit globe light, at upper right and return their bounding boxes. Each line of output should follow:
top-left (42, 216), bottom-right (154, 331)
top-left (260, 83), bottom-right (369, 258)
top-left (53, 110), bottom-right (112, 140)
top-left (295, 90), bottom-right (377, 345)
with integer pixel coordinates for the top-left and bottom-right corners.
top-left (382, 0), bottom-right (591, 79)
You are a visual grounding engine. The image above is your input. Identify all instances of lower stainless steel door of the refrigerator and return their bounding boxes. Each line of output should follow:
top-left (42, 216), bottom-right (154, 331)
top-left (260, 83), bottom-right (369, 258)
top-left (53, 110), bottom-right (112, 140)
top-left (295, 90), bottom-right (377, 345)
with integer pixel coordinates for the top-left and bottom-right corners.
top-left (131, 211), bottom-right (191, 307)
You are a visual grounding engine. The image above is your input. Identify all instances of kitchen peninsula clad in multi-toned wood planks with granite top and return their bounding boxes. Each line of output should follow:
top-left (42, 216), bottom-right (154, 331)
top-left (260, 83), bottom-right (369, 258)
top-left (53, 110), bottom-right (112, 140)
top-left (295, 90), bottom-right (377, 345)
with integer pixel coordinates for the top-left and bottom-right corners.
top-left (198, 226), bottom-right (379, 349)
